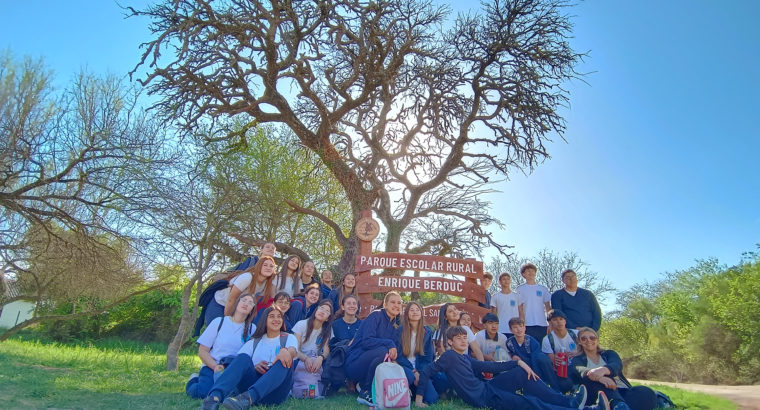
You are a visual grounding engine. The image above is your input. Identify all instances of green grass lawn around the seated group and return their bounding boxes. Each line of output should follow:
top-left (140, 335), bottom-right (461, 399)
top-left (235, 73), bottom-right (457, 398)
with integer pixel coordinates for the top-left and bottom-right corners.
top-left (0, 334), bottom-right (735, 410)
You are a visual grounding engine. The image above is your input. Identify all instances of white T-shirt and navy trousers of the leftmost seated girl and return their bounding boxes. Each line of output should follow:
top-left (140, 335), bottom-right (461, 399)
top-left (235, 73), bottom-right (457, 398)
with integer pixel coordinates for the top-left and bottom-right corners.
top-left (185, 316), bottom-right (256, 399)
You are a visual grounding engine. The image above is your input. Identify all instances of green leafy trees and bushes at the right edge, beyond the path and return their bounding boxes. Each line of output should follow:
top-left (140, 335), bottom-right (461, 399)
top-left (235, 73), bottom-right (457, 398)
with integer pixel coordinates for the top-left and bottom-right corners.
top-left (601, 245), bottom-right (760, 384)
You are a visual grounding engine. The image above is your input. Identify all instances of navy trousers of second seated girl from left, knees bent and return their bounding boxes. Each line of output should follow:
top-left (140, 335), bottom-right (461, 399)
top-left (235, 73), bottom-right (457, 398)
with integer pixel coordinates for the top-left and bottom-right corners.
top-left (209, 353), bottom-right (296, 406)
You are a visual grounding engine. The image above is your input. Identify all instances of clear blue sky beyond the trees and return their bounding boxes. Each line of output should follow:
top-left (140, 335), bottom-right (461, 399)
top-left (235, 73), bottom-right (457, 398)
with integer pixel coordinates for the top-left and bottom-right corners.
top-left (0, 0), bottom-right (760, 308)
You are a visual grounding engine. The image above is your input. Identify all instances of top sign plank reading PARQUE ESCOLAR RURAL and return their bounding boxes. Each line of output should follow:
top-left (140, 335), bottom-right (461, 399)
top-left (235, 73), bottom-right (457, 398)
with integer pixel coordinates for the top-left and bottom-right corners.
top-left (355, 252), bottom-right (483, 279)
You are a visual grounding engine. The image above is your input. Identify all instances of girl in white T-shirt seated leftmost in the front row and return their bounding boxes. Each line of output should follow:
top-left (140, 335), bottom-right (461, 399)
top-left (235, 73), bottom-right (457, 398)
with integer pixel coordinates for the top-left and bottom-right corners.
top-left (185, 293), bottom-right (256, 399)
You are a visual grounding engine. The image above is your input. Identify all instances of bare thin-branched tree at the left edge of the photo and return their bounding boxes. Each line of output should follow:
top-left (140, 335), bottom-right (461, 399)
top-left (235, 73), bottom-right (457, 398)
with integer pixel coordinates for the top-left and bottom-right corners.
top-left (0, 53), bottom-right (172, 337)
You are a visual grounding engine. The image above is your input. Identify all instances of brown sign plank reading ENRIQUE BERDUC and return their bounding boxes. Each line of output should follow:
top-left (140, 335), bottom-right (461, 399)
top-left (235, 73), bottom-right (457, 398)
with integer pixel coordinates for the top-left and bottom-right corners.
top-left (356, 275), bottom-right (486, 302)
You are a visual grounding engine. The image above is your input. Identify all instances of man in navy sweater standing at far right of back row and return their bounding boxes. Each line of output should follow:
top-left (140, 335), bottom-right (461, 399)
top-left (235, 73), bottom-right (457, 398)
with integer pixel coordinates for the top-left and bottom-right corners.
top-left (552, 269), bottom-right (602, 332)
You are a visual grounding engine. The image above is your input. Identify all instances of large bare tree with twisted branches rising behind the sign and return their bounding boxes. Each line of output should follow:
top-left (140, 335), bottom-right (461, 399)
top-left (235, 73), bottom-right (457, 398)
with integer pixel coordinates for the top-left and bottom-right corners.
top-left (130, 0), bottom-right (583, 270)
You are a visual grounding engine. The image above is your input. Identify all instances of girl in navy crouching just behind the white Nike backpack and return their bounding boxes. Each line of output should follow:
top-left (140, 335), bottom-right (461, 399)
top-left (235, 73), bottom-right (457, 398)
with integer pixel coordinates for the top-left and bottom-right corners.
top-left (345, 291), bottom-right (403, 406)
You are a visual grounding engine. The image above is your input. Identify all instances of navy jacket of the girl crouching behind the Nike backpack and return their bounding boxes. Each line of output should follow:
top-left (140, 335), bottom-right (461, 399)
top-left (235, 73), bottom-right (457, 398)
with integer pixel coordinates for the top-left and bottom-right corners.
top-left (346, 309), bottom-right (401, 363)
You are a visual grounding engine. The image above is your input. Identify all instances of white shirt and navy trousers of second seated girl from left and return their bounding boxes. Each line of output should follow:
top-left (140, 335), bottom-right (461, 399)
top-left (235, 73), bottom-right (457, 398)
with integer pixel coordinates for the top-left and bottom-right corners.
top-left (209, 334), bottom-right (298, 406)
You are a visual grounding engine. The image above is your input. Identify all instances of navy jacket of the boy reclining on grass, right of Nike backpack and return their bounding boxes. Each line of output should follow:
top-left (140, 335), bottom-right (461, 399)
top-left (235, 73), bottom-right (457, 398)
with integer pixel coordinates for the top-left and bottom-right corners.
top-left (417, 350), bottom-right (517, 407)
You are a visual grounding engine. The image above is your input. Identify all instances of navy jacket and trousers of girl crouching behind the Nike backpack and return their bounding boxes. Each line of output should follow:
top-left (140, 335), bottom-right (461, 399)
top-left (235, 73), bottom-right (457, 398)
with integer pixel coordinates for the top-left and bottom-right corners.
top-left (345, 309), bottom-right (401, 390)
